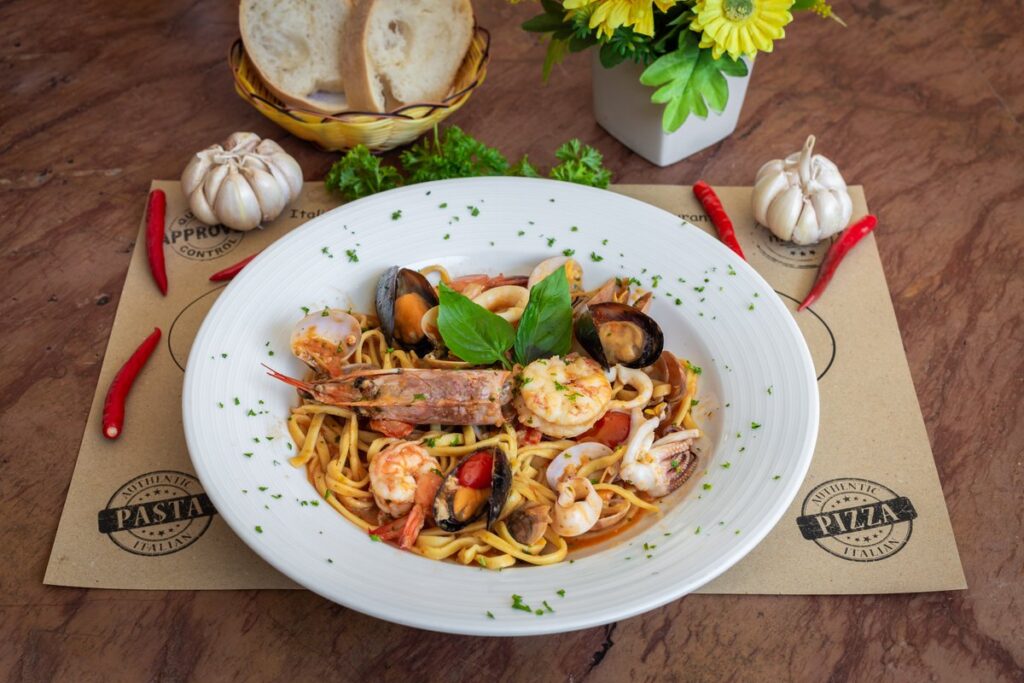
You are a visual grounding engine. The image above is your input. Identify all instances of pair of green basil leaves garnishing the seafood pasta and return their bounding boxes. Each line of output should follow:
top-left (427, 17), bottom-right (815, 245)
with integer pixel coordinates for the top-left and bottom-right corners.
top-left (437, 267), bottom-right (572, 368)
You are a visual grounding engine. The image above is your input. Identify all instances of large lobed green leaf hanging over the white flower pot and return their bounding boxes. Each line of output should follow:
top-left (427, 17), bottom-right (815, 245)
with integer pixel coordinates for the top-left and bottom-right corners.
top-left (640, 31), bottom-right (748, 132)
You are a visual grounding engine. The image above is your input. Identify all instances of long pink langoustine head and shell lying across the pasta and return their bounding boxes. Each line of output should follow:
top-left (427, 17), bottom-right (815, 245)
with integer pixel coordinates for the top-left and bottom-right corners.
top-left (267, 366), bottom-right (512, 426)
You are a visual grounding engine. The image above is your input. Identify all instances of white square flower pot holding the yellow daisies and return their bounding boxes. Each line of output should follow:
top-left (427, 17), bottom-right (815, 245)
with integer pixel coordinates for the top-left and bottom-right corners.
top-left (591, 50), bottom-right (754, 166)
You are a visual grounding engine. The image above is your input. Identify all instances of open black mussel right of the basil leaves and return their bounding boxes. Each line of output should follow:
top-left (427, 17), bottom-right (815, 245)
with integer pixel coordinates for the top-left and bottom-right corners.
top-left (573, 301), bottom-right (665, 368)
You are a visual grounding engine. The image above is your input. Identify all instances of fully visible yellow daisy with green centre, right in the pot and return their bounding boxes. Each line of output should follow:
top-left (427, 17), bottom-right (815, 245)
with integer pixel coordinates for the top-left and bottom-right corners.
top-left (690, 0), bottom-right (794, 59)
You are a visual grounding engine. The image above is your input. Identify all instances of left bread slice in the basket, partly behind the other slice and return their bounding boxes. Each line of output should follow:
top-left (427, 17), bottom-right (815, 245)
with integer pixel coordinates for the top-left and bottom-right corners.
top-left (239, 0), bottom-right (354, 114)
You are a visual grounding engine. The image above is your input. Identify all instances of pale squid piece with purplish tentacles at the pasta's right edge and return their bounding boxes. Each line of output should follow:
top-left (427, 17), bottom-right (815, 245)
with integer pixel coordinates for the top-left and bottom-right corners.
top-left (618, 408), bottom-right (700, 498)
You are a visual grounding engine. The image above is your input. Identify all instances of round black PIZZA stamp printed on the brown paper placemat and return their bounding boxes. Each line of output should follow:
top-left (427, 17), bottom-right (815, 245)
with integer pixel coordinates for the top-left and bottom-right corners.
top-left (797, 477), bottom-right (918, 562)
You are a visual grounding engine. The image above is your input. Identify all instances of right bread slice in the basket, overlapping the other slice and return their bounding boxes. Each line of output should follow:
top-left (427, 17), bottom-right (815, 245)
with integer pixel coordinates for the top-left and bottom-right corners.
top-left (342, 0), bottom-right (473, 112)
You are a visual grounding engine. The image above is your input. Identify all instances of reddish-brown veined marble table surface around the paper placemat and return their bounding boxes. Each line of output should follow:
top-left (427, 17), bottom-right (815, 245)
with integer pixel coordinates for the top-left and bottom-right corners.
top-left (0, 0), bottom-right (1024, 681)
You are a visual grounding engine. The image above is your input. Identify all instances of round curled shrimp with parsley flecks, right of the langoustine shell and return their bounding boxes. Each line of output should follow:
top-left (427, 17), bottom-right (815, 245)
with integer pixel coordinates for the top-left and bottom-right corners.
top-left (515, 353), bottom-right (611, 438)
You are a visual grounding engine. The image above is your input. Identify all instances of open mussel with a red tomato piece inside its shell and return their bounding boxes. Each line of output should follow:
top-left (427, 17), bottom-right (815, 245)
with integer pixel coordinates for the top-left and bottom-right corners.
top-left (434, 451), bottom-right (512, 531)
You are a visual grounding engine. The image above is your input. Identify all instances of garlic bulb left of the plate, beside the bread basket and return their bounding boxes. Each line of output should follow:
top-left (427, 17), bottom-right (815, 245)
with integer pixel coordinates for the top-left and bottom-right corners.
top-left (181, 133), bottom-right (302, 230)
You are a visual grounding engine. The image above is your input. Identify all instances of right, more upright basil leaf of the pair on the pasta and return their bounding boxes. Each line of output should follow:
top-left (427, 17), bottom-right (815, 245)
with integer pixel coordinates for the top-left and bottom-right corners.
top-left (515, 266), bottom-right (572, 366)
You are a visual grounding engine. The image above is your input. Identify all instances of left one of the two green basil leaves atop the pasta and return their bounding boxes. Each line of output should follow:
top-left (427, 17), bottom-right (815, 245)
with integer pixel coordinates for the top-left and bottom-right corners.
top-left (437, 283), bottom-right (515, 368)
